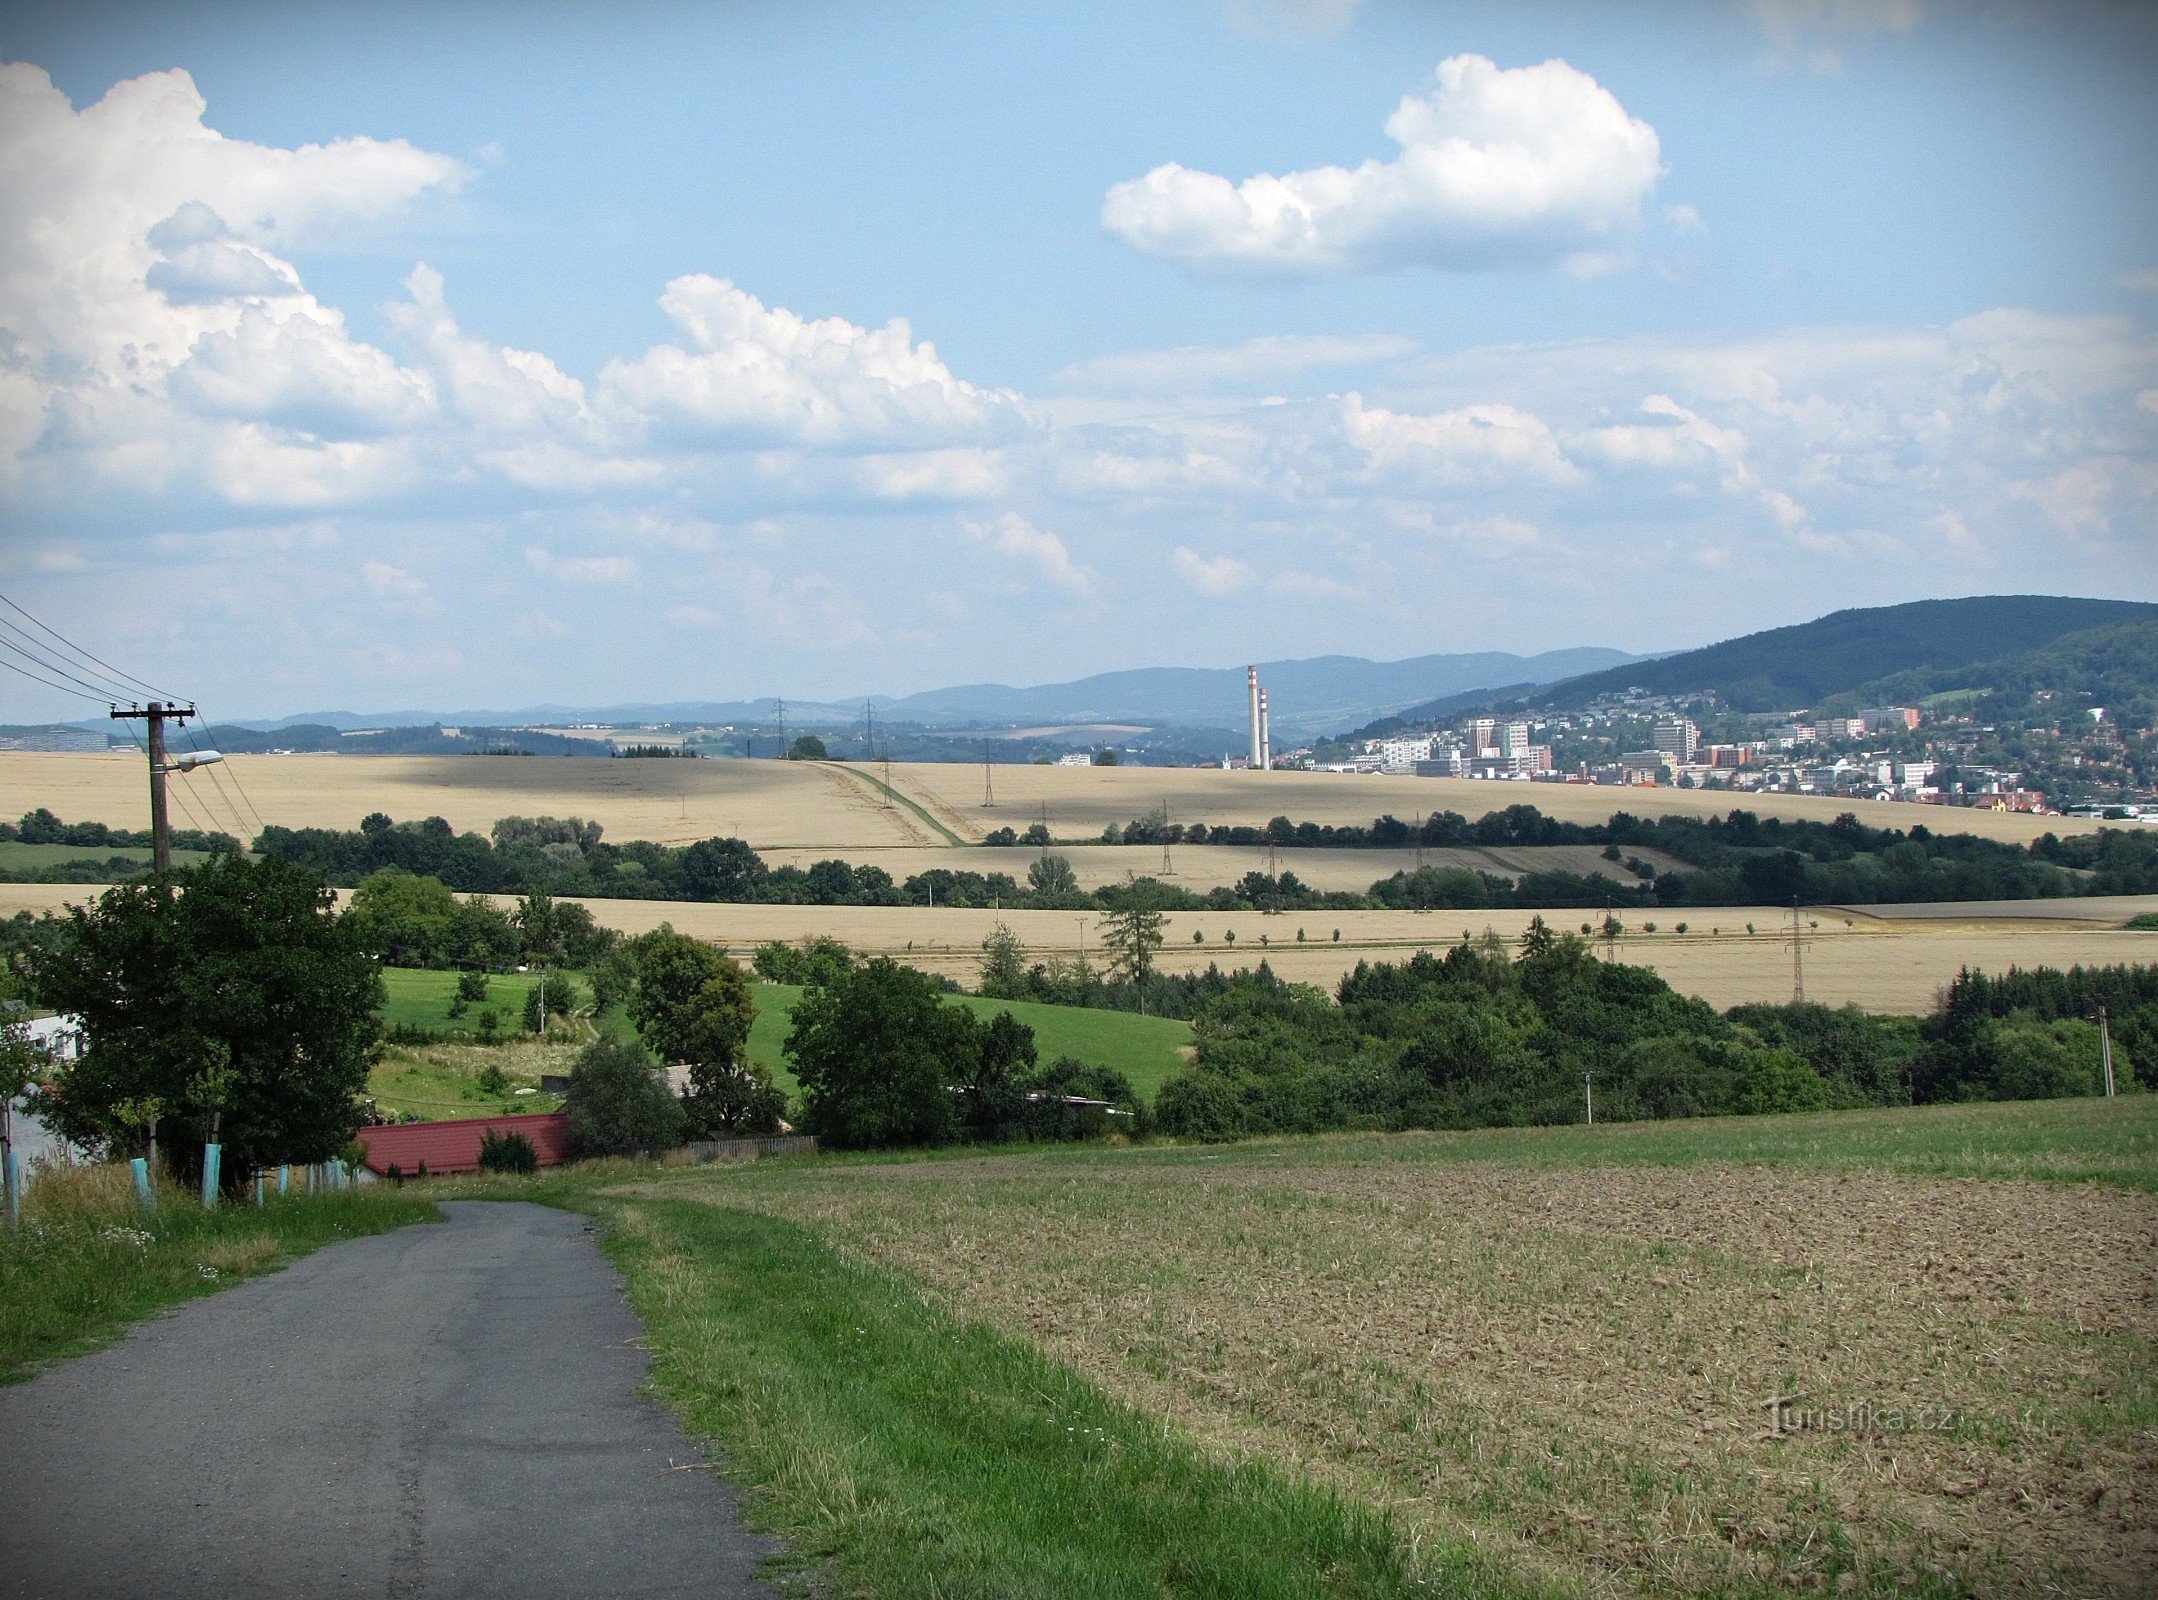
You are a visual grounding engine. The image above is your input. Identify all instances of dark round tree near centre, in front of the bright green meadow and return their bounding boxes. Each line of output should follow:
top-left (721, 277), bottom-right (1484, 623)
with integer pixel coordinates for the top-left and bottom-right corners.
top-left (786, 957), bottom-right (982, 1149)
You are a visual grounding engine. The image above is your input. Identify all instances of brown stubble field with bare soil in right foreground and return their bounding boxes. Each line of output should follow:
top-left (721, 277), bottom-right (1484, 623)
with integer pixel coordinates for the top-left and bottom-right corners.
top-left (667, 1099), bottom-right (2158, 1596)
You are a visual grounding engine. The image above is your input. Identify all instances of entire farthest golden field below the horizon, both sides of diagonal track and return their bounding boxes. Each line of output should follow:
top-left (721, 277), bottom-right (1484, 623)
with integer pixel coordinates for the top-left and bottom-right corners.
top-left (0, 751), bottom-right (2095, 850)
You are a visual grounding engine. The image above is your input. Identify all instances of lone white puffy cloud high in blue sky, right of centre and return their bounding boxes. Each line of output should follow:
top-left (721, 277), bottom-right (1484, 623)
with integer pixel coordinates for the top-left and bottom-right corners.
top-left (1101, 56), bottom-right (1662, 276)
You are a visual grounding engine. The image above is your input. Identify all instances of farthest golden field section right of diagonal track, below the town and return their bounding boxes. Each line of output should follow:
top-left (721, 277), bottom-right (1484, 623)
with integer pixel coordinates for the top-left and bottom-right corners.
top-left (878, 762), bottom-right (2098, 844)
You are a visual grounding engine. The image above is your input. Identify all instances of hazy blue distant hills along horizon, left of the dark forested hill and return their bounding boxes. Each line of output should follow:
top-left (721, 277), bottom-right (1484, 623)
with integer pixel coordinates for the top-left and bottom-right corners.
top-left (219, 648), bottom-right (1638, 745)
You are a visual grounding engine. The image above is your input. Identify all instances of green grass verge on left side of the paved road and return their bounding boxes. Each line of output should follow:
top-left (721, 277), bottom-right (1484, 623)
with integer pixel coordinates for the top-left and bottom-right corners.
top-left (0, 1166), bottom-right (438, 1382)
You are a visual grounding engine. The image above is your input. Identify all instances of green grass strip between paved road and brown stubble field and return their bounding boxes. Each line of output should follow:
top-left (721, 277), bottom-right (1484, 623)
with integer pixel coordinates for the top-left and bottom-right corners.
top-left (593, 1192), bottom-right (1524, 1600)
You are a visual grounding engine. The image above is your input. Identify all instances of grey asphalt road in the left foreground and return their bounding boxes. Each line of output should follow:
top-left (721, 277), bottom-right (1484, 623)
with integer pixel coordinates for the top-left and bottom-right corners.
top-left (0, 1203), bottom-right (768, 1600)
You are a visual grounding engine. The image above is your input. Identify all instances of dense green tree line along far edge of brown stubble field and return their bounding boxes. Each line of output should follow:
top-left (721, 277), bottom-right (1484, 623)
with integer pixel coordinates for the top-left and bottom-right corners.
top-left (1155, 920), bottom-right (2123, 1140)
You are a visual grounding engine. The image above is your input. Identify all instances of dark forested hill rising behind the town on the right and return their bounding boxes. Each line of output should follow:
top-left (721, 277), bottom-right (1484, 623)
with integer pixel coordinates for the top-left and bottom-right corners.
top-left (1360, 594), bottom-right (2158, 736)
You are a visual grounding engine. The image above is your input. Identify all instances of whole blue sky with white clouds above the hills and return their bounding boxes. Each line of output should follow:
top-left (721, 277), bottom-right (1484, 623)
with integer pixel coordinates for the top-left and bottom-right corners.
top-left (0, 0), bottom-right (2158, 721)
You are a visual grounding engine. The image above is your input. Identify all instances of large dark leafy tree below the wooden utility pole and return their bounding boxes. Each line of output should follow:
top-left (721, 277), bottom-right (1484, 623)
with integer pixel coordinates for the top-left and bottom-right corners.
top-left (37, 855), bottom-right (384, 1185)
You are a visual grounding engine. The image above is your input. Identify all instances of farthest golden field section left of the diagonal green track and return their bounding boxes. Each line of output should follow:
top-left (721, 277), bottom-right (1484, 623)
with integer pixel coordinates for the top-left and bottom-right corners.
top-left (0, 751), bottom-right (919, 851)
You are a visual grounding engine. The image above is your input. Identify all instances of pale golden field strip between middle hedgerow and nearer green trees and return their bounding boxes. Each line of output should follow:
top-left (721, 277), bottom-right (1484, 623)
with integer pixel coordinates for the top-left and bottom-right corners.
top-left (16, 872), bottom-right (2158, 1013)
